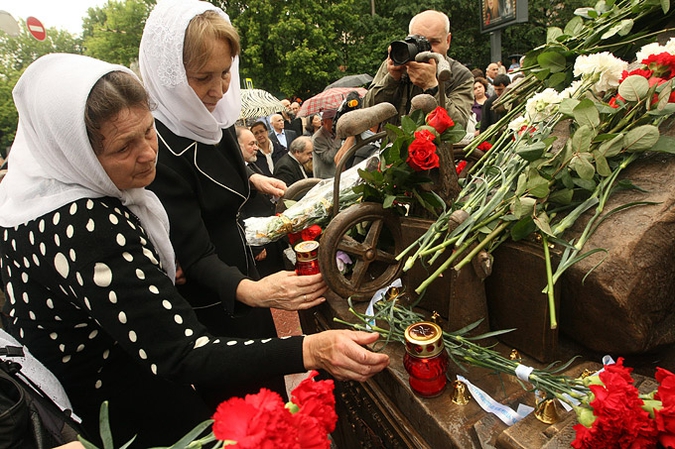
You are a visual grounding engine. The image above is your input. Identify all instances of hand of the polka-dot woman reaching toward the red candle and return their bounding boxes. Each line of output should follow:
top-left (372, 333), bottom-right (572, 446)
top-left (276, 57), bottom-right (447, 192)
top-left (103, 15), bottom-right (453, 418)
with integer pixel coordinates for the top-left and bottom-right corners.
top-left (302, 330), bottom-right (389, 382)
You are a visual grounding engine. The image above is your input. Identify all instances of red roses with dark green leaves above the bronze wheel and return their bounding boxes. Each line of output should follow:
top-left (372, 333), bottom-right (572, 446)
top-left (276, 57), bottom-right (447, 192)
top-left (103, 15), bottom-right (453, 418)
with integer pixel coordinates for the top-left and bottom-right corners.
top-left (353, 107), bottom-right (466, 214)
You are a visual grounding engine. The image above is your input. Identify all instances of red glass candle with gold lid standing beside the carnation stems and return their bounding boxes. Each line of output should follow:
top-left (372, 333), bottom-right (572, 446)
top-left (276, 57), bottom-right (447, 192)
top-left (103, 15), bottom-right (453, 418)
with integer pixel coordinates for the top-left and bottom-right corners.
top-left (403, 321), bottom-right (448, 398)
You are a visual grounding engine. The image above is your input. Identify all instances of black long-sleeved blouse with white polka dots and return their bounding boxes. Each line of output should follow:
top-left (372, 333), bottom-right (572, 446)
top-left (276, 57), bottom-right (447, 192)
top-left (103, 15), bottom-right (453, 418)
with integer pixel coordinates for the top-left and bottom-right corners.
top-left (1, 198), bottom-right (304, 447)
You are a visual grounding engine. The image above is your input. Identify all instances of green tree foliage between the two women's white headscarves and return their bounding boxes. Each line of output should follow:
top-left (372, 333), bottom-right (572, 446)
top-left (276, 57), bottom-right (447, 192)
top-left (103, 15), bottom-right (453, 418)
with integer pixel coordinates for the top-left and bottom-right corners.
top-left (82, 0), bottom-right (156, 66)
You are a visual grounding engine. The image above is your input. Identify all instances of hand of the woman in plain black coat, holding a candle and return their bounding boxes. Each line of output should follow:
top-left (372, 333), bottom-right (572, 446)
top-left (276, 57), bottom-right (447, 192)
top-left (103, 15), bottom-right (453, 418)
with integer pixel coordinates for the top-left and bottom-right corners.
top-left (237, 271), bottom-right (328, 310)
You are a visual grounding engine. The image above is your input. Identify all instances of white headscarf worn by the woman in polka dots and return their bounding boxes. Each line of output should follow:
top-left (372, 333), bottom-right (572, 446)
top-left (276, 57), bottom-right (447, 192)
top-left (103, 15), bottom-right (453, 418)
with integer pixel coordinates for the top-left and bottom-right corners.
top-left (0, 53), bottom-right (175, 280)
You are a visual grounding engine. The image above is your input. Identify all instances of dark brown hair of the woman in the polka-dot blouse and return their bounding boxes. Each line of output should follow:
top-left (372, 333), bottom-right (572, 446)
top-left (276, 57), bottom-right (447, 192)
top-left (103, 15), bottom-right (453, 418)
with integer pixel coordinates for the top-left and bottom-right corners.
top-left (84, 71), bottom-right (150, 154)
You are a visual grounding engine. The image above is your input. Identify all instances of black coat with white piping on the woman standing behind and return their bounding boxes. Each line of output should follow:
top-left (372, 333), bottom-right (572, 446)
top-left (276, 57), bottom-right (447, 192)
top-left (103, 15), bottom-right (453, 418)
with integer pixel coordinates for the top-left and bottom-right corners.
top-left (148, 121), bottom-right (285, 403)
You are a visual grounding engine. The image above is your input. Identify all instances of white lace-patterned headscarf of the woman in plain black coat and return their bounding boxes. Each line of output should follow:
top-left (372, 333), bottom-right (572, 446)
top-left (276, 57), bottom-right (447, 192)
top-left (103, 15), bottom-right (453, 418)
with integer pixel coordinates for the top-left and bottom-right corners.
top-left (138, 0), bottom-right (241, 145)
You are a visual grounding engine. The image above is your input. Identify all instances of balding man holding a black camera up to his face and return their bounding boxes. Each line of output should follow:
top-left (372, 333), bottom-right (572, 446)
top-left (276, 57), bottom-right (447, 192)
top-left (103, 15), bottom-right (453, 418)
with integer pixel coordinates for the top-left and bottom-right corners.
top-left (364, 10), bottom-right (473, 127)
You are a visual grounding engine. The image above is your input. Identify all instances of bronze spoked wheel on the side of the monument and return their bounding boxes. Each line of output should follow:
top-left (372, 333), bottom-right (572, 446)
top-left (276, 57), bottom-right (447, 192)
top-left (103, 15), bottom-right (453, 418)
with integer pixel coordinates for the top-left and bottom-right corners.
top-left (319, 203), bottom-right (403, 301)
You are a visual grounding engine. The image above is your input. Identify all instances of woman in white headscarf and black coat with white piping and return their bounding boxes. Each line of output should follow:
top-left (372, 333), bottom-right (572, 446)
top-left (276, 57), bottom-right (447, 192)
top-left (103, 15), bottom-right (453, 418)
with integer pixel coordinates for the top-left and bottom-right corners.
top-left (139, 0), bottom-right (344, 402)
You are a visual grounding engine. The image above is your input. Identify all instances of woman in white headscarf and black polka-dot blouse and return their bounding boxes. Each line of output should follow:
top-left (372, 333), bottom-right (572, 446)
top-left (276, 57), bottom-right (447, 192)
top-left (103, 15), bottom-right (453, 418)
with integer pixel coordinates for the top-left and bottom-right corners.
top-left (0, 54), bottom-right (387, 447)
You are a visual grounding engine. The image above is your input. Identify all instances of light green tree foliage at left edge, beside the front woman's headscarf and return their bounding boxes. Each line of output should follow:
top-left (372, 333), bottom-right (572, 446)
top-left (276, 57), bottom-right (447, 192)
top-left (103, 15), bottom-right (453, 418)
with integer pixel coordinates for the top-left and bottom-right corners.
top-left (0, 19), bottom-right (81, 157)
